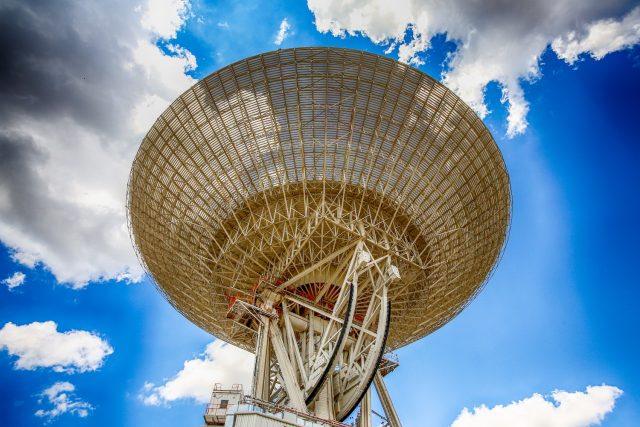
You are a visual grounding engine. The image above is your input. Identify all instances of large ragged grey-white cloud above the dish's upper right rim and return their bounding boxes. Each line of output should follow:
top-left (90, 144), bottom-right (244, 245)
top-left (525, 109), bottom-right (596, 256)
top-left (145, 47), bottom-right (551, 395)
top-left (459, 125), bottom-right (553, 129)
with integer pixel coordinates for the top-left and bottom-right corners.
top-left (308, 0), bottom-right (640, 137)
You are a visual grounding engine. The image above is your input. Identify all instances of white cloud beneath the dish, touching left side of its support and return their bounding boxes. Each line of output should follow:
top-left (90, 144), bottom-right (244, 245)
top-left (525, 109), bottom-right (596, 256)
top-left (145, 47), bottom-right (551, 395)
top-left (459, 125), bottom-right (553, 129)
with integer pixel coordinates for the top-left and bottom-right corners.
top-left (140, 340), bottom-right (253, 405)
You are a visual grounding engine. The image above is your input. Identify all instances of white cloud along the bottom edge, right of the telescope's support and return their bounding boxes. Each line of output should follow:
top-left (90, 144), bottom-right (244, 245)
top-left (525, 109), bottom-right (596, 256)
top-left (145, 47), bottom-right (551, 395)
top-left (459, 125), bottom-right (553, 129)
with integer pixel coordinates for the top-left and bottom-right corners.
top-left (451, 385), bottom-right (622, 427)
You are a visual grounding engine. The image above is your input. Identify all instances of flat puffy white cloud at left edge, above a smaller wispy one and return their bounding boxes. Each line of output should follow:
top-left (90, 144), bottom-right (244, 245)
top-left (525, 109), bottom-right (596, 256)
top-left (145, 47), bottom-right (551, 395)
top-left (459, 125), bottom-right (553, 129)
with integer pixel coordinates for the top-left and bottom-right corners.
top-left (0, 320), bottom-right (113, 373)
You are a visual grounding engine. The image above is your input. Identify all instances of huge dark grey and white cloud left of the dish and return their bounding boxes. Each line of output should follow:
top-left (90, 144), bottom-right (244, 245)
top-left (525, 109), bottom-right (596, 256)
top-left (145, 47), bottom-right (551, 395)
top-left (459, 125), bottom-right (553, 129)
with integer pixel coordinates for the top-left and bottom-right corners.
top-left (0, 0), bottom-right (197, 287)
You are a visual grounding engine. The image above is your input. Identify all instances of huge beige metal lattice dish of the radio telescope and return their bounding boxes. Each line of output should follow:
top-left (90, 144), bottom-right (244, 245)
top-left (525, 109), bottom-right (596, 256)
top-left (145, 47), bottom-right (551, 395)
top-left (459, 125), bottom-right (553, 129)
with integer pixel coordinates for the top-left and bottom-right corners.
top-left (128, 48), bottom-right (510, 351)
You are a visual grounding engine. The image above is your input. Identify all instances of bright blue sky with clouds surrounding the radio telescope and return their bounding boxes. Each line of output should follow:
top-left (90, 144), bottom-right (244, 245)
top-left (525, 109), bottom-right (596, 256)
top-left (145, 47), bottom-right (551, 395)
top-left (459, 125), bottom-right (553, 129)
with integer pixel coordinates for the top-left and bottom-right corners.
top-left (0, 0), bottom-right (640, 427)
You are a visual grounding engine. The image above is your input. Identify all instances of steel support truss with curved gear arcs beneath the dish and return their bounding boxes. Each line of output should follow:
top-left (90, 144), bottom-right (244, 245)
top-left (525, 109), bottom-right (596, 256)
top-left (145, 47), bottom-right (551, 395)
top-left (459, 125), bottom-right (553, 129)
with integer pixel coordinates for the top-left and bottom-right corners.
top-left (253, 241), bottom-right (399, 420)
